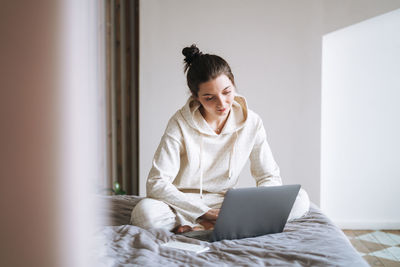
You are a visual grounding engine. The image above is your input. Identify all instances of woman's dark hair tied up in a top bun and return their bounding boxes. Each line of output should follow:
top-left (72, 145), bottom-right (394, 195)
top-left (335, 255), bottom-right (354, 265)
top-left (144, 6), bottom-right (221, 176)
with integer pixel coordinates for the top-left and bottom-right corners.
top-left (182, 44), bottom-right (235, 97)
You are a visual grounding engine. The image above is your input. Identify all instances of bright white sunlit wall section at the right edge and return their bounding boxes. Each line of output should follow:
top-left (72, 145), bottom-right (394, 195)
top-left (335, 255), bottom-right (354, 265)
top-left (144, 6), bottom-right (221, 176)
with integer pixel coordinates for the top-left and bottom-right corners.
top-left (321, 9), bottom-right (400, 229)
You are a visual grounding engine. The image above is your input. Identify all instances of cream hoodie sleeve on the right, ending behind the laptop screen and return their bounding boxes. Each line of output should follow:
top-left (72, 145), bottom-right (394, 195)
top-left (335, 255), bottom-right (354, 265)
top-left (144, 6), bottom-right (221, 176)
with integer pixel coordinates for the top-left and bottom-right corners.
top-left (250, 119), bottom-right (282, 186)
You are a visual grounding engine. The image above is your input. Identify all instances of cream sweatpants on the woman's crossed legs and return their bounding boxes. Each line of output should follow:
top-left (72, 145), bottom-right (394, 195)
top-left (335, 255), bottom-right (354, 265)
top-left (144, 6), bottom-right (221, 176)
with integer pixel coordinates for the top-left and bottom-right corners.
top-left (131, 188), bottom-right (310, 231)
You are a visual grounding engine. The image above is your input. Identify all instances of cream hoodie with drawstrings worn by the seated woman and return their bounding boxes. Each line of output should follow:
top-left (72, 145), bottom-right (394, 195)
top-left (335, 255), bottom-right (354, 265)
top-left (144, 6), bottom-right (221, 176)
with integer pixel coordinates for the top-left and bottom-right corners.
top-left (147, 95), bottom-right (282, 223)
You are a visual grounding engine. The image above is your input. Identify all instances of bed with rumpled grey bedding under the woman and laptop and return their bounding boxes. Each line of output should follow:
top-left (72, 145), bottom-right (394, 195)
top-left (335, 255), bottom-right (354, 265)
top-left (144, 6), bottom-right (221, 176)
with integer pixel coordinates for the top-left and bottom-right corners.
top-left (95, 196), bottom-right (369, 266)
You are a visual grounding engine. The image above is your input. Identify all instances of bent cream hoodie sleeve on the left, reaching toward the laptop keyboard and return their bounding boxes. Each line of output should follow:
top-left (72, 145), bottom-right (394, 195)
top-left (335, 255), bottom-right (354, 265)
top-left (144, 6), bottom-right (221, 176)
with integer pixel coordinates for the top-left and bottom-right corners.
top-left (146, 120), bottom-right (210, 223)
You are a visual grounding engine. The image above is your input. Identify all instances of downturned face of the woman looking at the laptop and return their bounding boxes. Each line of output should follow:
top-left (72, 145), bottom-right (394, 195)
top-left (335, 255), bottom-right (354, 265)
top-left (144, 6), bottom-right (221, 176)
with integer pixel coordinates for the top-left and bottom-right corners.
top-left (196, 74), bottom-right (235, 119)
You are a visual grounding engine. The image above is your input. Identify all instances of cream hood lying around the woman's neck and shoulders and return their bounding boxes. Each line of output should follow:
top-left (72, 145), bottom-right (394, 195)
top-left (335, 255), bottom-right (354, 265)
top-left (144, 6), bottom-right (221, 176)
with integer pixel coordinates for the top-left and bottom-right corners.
top-left (180, 95), bottom-right (248, 136)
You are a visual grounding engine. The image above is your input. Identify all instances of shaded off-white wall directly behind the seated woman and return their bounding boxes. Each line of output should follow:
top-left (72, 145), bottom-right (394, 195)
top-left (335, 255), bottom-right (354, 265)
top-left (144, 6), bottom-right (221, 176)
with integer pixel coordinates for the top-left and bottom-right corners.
top-left (139, 0), bottom-right (400, 210)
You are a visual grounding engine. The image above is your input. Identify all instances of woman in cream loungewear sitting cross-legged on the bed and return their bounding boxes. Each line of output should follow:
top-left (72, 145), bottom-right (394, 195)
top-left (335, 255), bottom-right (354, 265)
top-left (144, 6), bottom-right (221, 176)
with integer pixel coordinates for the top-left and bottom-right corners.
top-left (131, 45), bottom-right (309, 233)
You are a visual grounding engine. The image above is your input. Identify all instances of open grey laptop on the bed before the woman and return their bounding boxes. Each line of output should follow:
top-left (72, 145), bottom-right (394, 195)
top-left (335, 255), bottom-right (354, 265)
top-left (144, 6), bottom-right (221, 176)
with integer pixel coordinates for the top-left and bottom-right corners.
top-left (182, 184), bottom-right (300, 242)
